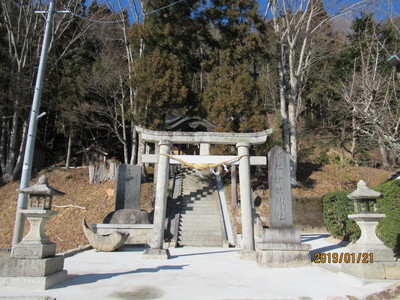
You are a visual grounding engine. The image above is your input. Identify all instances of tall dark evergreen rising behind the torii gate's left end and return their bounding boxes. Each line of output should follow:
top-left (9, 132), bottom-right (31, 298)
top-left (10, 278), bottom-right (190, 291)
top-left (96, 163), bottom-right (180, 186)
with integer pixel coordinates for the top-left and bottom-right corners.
top-left (132, 0), bottom-right (205, 120)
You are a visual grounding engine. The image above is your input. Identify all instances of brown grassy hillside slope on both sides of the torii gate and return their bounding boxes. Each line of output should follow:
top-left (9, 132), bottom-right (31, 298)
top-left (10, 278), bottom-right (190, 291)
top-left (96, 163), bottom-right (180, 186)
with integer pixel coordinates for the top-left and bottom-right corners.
top-left (0, 165), bottom-right (391, 252)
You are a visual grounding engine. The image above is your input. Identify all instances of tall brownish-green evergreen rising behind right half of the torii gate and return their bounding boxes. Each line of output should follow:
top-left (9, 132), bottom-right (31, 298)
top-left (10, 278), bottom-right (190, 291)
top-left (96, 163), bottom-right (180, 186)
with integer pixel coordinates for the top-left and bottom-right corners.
top-left (203, 0), bottom-right (266, 132)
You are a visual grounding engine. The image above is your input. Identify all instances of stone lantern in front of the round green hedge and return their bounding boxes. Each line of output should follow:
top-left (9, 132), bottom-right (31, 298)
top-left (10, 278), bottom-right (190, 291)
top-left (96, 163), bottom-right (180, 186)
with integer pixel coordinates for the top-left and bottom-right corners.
top-left (341, 180), bottom-right (400, 280)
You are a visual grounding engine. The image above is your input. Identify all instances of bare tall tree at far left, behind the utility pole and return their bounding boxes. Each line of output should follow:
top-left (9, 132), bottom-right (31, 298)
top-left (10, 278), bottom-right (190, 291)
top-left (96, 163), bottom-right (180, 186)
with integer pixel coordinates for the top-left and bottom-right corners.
top-left (0, 0), bottom-right (99, 182)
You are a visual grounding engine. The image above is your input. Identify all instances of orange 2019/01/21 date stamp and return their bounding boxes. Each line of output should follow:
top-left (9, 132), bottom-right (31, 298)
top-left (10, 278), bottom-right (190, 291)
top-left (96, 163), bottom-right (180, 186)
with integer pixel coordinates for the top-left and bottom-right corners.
top-left (314, 252), bottom-right (374, 264)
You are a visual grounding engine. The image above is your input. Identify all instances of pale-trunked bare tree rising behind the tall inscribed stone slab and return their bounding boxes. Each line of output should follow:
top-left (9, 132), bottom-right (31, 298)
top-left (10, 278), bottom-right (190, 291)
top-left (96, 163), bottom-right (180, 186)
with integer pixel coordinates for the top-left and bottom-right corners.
top-left (265, 0), bottom-right (370, 185)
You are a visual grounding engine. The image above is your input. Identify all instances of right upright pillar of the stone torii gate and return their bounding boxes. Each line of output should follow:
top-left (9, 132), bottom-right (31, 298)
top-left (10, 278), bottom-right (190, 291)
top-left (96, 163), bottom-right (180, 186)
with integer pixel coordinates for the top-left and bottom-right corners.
top-left (236, 142), bottom-right (255, 259)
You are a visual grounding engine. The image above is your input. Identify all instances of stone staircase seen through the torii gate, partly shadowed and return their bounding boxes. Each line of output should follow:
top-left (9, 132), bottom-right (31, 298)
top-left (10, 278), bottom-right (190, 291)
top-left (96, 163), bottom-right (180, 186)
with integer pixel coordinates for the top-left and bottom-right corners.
top-left (178, 171), bottom-right (224, 247)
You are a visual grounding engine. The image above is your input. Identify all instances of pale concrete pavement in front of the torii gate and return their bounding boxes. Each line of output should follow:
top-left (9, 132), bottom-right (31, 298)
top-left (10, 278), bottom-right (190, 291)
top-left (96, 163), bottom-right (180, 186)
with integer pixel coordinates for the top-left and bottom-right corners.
top-left (0, 234), bottom-right (396, 300)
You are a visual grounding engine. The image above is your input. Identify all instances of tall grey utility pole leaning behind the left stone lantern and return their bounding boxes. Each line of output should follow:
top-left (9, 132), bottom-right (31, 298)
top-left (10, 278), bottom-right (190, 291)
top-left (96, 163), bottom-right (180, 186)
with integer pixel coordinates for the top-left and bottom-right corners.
top-left (12, 1), bottom-right (64, 247)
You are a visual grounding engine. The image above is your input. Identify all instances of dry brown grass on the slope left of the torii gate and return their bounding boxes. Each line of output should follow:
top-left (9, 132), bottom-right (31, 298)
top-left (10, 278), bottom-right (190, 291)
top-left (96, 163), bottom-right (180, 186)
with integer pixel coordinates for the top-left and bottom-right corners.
top-left (0, 169), bottom-right (152, 252)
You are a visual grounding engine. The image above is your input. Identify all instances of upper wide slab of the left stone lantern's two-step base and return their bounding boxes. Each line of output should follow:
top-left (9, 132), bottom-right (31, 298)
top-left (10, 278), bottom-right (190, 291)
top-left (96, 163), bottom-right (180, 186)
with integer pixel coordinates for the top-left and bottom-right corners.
top-left (0, 256), bottom-right (64, 277)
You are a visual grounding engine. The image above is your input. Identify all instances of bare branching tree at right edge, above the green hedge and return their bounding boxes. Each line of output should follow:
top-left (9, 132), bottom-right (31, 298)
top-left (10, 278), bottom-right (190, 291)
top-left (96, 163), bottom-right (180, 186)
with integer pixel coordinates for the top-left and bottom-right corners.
top-left (342, 32), bottom-right (400, 164)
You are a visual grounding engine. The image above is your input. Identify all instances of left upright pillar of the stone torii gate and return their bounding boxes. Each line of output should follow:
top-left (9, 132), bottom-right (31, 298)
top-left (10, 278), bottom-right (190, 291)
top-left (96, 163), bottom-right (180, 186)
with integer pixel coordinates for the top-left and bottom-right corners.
top-left (142, 141), bottom-right (172, 259)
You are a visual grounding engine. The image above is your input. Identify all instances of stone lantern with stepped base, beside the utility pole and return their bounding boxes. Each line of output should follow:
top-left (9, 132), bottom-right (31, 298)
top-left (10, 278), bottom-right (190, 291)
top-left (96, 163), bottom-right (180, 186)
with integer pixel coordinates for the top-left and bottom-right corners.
top-left (0, 176), bottom-right (67, 290)
